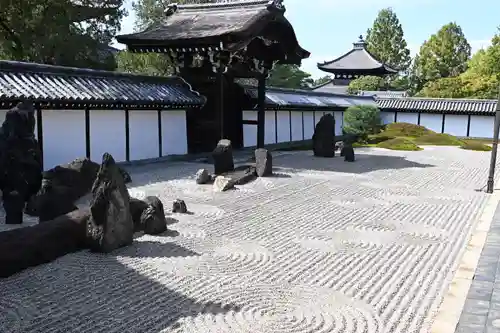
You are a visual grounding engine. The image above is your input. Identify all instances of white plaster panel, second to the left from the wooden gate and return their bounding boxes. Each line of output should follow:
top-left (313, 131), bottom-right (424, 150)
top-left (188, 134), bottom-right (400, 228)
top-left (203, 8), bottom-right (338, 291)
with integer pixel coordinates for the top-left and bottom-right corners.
top-left (129, 110), bottom-right (159, 161)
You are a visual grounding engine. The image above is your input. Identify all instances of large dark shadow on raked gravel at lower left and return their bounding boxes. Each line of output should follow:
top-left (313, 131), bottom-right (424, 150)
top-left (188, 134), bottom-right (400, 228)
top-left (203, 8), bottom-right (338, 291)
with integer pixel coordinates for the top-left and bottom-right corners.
top-left (0, 242), bottom-right (241, 332)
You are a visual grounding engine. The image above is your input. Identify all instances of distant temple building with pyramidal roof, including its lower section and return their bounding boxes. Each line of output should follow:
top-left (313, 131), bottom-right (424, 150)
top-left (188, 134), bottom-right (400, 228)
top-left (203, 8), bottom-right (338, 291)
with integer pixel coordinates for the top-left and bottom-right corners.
top-left (314, 36), bottom-right (398, 94)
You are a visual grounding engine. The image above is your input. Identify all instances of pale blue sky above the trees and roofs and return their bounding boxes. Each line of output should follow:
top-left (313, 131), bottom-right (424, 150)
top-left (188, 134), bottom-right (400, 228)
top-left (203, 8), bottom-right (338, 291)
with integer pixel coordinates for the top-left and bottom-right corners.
top-left (114, 0), bottom-right (500, 78)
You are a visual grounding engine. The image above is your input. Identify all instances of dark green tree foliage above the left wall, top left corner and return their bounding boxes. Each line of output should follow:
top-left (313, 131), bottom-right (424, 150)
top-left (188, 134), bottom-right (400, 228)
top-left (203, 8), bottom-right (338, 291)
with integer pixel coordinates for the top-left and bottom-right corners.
top-left (0, 0), bottom-right (126, 69)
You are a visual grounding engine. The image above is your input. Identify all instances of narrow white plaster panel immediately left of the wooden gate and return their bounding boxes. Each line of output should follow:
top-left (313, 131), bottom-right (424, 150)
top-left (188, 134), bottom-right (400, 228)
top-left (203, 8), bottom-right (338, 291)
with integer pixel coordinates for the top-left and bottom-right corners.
top-left (161, 110), bottom-right (188, 156)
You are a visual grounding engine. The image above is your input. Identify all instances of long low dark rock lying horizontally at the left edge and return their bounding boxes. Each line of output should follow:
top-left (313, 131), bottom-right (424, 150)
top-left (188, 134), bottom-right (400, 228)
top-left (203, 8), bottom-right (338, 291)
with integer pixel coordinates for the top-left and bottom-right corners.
top-left (0, 209), bottom-right (90, 278)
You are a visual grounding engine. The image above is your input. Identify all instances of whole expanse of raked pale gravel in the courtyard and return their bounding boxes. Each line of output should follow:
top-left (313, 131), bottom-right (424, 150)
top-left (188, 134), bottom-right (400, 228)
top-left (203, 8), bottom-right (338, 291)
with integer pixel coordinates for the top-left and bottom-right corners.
top-left (0, 147), bottom-right (500, 333)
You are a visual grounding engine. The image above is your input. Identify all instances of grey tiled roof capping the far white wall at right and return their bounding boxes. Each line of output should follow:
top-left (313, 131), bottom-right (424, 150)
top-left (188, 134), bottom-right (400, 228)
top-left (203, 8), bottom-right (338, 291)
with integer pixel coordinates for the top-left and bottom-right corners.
top-left (376, 97), bottom-right (498, 114)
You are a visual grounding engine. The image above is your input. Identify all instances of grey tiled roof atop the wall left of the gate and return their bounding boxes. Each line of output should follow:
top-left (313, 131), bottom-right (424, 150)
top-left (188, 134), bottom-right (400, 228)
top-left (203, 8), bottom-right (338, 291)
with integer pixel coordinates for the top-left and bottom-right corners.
top-left (0, 61), bottom-right (205, 108)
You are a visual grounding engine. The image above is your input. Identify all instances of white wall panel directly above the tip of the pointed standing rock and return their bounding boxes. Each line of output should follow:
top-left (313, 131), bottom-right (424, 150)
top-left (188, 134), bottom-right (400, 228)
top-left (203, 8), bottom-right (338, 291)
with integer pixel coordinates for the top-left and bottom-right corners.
top-left (90, 110), bottom-right (126, 163)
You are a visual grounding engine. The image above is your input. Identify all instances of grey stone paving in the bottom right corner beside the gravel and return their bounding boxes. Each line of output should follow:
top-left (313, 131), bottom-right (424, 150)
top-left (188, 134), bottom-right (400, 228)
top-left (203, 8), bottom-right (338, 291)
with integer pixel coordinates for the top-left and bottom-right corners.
top-left (455, 200), bottom-right (500, 333)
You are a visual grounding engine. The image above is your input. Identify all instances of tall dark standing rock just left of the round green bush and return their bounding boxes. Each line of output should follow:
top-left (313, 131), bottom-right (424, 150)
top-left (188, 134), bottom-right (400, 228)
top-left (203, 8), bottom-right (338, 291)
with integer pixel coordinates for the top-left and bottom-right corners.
top-left (313, 113), bottom-right (335, 157)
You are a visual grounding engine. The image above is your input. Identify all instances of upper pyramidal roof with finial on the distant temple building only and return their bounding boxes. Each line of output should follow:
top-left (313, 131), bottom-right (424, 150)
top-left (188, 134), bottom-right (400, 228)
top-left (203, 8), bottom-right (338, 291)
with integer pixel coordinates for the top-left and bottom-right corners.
top-left (318, 36), bottom-right (398, 75)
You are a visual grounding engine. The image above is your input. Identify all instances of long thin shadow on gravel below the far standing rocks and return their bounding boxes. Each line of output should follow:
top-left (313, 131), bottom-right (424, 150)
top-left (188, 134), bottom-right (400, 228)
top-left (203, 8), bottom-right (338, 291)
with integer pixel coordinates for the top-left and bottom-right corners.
top-left (273, 154), bottom-right (434, 174)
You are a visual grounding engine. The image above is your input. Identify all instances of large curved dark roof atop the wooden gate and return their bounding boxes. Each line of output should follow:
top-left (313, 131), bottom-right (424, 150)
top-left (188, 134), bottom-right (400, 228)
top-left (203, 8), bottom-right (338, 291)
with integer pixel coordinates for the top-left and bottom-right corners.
top-left (116, 0), bottom-right (310, 64)
